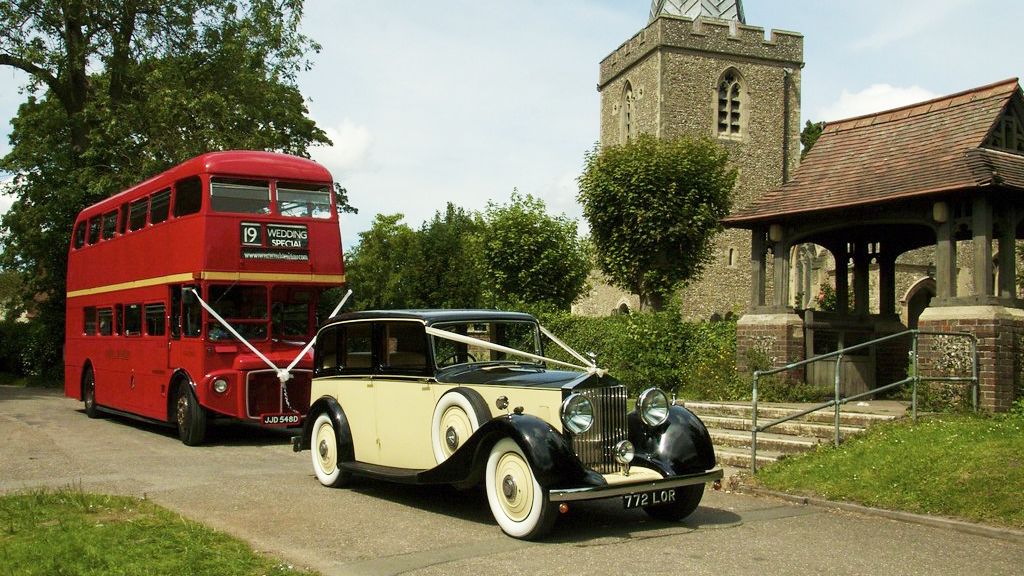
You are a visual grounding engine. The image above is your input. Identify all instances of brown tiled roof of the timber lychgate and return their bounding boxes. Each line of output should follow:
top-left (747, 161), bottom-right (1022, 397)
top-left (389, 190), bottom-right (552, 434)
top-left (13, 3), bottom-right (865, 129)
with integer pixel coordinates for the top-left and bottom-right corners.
top-left (725, 78), bottom-right (1024, 228)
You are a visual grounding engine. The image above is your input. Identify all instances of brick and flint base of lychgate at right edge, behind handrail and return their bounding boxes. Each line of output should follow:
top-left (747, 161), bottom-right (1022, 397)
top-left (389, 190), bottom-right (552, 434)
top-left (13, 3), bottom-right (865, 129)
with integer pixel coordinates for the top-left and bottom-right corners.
top-left (918, 305), bottom-right (1024, 412)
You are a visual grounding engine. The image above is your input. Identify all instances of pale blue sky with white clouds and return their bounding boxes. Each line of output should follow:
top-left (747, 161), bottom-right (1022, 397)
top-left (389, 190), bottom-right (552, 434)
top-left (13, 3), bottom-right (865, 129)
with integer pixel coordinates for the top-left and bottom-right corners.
top-left (0, 0), bottom-right (1024, 244)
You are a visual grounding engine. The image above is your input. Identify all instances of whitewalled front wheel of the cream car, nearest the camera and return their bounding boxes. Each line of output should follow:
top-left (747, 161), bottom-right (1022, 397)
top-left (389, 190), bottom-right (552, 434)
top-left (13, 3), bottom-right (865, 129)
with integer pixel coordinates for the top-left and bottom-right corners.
top-left (484, 438), bottom-right (557, 540)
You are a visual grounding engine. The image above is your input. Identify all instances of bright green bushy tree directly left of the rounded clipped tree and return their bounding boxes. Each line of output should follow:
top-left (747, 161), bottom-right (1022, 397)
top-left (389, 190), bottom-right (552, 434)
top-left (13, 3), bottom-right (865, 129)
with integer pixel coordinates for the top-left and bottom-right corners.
top-left (483, 192), bottom-right (591, 310)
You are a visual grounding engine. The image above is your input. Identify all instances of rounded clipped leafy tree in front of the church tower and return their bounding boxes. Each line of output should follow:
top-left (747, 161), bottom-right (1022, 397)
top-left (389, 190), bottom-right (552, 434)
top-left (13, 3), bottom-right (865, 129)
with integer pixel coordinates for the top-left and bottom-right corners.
top-left (578, 134), bottom-right (736, 310)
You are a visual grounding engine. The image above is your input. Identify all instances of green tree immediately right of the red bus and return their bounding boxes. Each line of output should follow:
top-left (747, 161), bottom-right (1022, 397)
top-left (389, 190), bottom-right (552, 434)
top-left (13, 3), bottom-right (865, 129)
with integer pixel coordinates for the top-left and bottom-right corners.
top-left (345, 214), bottom-right (419, 310)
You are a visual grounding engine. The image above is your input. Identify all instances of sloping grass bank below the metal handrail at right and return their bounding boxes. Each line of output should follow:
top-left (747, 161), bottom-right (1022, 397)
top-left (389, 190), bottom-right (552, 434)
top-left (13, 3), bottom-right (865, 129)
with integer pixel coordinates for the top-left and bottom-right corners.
top-left (755, 414), bottom-right (1024, 529)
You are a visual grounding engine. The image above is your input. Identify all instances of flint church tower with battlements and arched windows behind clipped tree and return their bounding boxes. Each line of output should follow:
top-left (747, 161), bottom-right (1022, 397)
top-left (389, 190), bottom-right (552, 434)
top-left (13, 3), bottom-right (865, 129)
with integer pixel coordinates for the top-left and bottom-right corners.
top-left (577, 0), bottom-right (804, 319)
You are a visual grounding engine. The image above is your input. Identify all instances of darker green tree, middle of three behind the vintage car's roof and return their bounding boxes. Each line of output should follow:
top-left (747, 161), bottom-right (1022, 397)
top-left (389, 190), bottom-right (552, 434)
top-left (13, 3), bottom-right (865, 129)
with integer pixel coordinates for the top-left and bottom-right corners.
top-left (412, 202), bottom-right (486, 307)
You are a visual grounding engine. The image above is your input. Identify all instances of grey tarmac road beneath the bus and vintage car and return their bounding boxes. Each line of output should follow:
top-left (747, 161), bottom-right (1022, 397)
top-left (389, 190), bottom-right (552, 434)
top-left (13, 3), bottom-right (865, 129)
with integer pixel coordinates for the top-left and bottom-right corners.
top-left (0, 386), bottom-right (1024, 576)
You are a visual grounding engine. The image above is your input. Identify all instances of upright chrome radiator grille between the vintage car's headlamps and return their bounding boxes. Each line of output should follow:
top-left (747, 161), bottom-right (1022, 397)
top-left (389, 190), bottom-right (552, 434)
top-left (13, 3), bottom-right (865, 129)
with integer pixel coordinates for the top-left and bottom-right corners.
top-left (572, 385), bottom-right (627, 474)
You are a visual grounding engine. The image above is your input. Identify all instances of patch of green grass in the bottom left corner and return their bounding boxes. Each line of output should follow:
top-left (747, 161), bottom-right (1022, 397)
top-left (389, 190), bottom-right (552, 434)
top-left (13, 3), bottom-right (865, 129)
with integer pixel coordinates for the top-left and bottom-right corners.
top-left (0, 489), bottom-right (309, 576)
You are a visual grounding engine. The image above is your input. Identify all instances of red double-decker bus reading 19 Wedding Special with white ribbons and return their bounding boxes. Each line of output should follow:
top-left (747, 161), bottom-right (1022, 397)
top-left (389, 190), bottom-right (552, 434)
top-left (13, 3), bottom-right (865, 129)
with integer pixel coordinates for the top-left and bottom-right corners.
top-left (65, 152), bottom-right (345, 445)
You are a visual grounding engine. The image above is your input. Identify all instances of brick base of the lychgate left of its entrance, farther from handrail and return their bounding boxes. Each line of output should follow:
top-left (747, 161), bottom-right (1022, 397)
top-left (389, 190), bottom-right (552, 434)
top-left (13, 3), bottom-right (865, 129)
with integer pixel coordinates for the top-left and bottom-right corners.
top-left (736, 313), bottom-right (805, 382)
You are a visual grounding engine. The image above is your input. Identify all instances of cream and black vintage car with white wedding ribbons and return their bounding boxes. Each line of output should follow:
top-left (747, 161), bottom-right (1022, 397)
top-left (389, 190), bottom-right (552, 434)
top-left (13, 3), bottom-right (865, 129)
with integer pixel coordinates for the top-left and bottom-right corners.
top-left (293, 311), bottom-right (722, 538)
